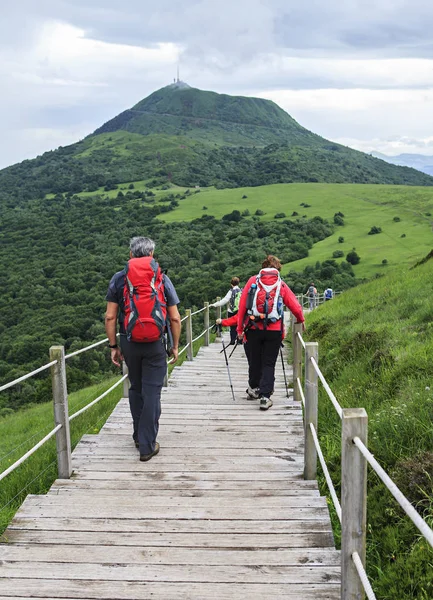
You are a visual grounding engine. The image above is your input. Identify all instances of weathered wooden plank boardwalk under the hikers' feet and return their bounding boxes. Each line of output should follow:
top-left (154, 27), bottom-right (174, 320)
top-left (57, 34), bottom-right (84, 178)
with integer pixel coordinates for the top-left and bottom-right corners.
top-left (0, 343), bottom-right (340, 600)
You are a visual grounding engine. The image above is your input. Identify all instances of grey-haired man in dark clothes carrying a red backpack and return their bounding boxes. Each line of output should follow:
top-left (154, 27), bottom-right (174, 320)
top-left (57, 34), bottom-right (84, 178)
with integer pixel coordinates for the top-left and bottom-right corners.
top-left (105, 237), bottom-right (181, 461)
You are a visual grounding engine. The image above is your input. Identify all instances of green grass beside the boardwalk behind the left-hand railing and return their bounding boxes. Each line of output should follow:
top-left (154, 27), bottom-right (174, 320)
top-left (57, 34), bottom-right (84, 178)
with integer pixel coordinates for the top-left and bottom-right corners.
top-left (0, 377), bottom-right (122, 533)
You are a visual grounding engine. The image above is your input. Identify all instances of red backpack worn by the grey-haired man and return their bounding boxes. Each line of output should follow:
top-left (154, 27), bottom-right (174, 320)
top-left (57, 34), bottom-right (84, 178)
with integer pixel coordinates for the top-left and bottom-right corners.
top-left (123, 256), bottom-right (167, 342)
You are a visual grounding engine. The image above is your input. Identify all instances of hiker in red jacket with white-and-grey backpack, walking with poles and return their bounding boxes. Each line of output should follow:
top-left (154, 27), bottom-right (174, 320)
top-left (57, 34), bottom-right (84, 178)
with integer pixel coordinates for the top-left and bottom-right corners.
top-left (237, 256), bottom-right (304, 410)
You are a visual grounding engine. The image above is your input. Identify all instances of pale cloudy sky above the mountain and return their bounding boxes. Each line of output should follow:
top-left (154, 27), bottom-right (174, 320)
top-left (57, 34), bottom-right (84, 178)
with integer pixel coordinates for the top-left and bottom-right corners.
top-left (0, 0), bottom-right (433, 168)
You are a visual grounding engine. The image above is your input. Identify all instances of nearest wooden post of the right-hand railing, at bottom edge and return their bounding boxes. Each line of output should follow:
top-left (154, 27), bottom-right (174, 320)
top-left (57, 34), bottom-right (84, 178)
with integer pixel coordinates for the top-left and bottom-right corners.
top-left (341, 408), bottom-right (368, 600)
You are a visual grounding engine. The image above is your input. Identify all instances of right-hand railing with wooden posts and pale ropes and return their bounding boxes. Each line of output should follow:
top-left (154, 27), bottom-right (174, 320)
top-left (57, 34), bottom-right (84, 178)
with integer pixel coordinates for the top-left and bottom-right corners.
top-left (292, 323), bottom-right (433, 600)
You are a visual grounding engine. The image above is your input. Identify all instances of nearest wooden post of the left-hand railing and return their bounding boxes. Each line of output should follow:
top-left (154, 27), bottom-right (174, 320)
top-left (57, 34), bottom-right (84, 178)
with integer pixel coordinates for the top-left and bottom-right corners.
top-left (50, 346), bottom-right (72, 479)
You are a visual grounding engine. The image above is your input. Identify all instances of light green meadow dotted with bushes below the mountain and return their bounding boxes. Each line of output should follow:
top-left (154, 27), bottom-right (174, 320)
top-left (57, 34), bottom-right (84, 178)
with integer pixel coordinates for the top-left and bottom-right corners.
top-left (159, 183), bottom-right (433, 278)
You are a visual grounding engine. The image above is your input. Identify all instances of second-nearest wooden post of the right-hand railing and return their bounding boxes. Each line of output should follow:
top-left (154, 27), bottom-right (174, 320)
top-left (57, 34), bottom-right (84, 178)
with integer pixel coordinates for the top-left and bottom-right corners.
top-left (304, 342), bottom-right (319, 479)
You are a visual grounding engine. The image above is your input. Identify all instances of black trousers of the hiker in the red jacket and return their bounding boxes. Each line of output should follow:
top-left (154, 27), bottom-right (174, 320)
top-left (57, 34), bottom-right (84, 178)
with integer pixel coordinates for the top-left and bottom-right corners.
top-left (247, 329), bottom-right (281, 398)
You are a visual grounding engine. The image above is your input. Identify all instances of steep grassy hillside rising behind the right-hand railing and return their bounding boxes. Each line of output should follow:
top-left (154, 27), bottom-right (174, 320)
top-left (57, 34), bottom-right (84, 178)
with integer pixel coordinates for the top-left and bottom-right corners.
top-left (306, 260), bottom-right (433, 600)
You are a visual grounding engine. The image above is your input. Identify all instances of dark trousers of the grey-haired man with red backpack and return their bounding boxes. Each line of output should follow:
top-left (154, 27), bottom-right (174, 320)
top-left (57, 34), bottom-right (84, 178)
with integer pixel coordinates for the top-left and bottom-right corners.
top-left (120, 335), bottom-right (167, 454)
